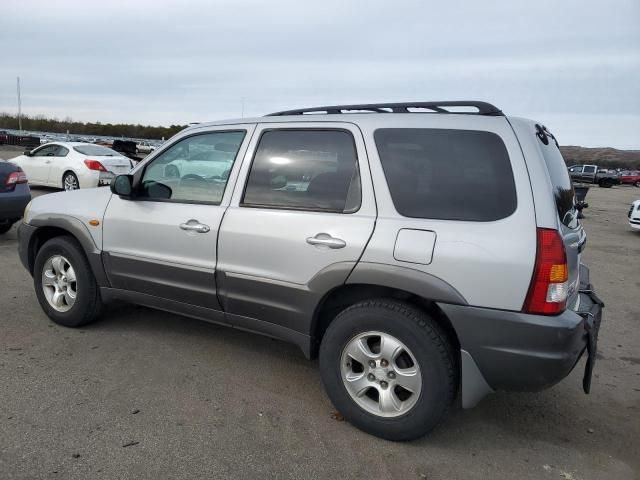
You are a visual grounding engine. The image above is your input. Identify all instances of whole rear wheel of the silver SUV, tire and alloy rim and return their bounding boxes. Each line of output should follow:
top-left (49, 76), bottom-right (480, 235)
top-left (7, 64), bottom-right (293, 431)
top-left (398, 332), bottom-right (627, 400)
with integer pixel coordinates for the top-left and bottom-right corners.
top-left (320, 299), bottom-right (457, 440)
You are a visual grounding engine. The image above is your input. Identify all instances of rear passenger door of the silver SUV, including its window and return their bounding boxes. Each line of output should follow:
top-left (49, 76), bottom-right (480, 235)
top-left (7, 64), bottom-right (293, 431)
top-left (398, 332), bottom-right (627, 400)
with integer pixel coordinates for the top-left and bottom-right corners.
top-left (218, 122), bottom-right (376, 334)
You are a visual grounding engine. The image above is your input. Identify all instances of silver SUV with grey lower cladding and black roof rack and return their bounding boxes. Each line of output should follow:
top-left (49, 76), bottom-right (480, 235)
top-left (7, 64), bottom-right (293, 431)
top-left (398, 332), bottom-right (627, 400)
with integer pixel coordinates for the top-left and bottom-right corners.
top-left (19, 102), bottom-right (603, 440)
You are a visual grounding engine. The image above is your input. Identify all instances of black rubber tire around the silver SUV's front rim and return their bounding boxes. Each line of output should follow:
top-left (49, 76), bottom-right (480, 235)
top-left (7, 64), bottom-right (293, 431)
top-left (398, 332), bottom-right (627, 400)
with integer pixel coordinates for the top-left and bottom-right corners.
top-left (33, 236), bottom-right (102, 327)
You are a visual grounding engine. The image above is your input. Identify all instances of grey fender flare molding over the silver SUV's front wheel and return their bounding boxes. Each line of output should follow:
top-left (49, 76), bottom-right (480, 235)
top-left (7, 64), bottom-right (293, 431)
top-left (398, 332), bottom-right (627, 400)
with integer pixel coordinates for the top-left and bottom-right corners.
top-left (28, 213), bottom-right (109, 287)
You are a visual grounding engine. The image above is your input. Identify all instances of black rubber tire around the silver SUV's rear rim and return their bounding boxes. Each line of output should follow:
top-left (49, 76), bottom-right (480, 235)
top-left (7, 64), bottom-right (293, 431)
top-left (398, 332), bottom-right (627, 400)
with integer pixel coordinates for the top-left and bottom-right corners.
top-left (320, 299), bottom-right (458, 441)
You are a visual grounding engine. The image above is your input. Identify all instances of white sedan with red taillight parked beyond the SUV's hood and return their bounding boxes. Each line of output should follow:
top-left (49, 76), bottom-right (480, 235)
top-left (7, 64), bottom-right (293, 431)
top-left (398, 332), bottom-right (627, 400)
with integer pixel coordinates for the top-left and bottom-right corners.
top-left (9, 142), bottom-right (133, 190)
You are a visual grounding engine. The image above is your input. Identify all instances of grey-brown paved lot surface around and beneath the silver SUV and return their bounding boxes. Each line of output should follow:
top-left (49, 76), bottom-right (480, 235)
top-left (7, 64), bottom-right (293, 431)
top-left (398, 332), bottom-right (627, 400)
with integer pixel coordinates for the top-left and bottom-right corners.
top-left (0, 164), bottom-right (640, 480)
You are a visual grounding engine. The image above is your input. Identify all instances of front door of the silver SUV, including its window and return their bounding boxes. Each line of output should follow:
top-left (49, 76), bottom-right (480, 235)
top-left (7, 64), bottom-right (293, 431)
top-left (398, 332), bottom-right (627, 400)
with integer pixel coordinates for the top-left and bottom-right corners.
top-left (103, 125), bottom-right (254, 310)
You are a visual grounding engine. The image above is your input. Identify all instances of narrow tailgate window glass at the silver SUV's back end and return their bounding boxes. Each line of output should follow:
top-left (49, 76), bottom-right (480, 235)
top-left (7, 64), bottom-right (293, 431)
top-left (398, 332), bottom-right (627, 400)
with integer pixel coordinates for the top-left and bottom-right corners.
top-left (539, 137), bottom-right (576, 228)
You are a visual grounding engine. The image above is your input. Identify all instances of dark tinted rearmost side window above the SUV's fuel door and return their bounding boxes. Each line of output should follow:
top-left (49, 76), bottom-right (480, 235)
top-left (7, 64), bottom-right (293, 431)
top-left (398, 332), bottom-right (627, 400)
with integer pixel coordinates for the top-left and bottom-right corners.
top-left (374, 128), bottom-right (517, 222)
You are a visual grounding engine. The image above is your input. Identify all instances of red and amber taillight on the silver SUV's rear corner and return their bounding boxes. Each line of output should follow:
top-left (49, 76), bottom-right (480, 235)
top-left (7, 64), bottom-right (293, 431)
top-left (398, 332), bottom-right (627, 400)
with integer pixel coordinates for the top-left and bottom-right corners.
top-left (523, 228), bottom-right (569, 315)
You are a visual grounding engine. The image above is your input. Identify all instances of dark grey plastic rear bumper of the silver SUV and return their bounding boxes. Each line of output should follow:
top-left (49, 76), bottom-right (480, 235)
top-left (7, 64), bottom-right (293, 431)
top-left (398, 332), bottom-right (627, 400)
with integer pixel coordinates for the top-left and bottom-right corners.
top-left (440, 266), bottom-right (603, 407)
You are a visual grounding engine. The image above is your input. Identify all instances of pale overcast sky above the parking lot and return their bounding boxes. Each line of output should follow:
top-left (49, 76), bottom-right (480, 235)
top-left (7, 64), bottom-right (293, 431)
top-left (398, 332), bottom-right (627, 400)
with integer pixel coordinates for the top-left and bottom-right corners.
top-left (0, 0), bottom-right (640, 149)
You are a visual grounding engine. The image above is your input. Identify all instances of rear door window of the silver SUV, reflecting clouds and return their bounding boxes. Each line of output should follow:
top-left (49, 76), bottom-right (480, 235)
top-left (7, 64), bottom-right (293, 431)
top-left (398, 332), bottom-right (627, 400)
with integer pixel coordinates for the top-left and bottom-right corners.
top-left (242, 129), bottom-right (361, 213)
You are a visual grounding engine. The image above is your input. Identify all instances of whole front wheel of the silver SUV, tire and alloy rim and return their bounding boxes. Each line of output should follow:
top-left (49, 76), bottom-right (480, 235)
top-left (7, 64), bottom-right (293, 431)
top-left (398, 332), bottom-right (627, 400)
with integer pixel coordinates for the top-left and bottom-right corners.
top-left (33, 237), bottom-right (102, 327)
